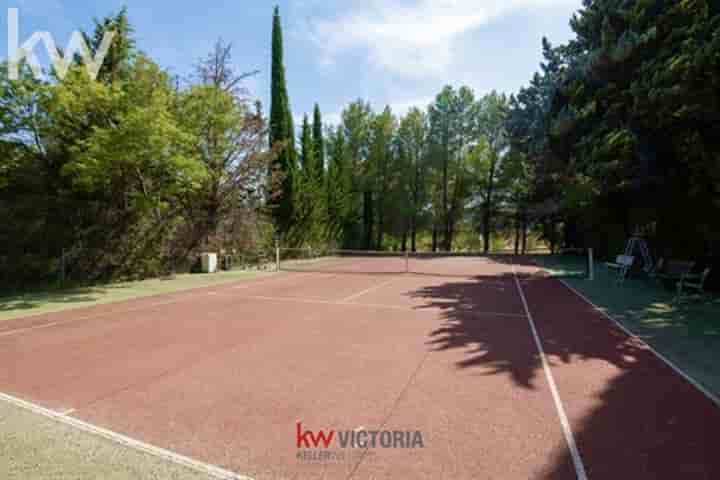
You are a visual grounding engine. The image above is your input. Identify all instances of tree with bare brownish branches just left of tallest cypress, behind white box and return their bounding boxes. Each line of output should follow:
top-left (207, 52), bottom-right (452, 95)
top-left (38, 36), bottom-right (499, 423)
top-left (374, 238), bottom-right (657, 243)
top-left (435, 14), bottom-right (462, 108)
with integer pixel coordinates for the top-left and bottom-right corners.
top-left (179, 42), bottom-right (273, 251)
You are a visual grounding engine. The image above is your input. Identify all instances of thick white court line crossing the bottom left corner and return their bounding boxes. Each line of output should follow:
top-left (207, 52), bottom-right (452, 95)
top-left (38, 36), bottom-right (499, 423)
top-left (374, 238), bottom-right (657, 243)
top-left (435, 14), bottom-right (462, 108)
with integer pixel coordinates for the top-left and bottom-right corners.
top-left (0, 393), bottom-right (253, 480)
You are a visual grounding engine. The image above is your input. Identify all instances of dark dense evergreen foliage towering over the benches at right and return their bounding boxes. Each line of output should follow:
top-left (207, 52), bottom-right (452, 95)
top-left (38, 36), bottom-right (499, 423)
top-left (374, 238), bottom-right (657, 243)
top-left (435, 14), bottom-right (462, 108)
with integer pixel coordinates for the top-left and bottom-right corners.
top-left (508, 0), bottom-right (720, 257)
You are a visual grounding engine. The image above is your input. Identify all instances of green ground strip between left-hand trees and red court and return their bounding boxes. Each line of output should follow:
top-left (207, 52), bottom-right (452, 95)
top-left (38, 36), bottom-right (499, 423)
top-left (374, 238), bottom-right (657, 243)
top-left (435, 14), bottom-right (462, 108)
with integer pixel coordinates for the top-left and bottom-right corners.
top-left (0, 271), bottom-right (268, 321)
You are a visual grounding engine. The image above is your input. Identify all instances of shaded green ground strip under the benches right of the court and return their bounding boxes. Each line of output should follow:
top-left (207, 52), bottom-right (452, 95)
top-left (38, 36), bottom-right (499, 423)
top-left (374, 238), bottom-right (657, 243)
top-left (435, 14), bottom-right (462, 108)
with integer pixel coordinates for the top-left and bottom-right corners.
top-left (537, 256), bottom-right (720, 394)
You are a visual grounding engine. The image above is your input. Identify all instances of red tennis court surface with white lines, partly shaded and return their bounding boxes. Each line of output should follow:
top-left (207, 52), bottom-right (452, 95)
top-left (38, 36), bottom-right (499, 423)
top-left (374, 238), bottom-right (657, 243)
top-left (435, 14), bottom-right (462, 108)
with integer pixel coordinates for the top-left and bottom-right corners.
top-left (0, 259), bottom-right (720, 480)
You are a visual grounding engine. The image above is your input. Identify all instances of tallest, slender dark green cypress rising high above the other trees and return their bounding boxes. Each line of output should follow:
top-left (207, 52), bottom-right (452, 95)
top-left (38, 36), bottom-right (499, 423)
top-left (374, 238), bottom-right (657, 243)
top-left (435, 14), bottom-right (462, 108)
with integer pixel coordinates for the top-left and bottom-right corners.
top-left (270, 6), bottom-right (296, 239)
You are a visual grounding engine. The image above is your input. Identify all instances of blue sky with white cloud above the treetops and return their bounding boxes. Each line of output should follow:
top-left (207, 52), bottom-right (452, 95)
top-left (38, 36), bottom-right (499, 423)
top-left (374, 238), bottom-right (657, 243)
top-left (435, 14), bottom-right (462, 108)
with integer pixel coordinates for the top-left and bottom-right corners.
top-left (0, 0), bottom-right (581, 125)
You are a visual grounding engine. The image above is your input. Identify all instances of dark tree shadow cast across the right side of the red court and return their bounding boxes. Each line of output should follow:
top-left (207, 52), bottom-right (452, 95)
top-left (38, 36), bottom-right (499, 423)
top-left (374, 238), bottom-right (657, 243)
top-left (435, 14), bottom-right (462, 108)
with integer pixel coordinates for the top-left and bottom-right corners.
top-left (412, 261), bottom-right (720, 480)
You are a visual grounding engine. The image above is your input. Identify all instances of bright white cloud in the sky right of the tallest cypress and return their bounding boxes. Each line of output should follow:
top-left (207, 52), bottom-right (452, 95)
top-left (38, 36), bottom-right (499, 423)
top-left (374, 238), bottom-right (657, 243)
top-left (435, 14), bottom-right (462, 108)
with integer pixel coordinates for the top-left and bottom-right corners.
top-left (308, 0), bottom-right (577, 77)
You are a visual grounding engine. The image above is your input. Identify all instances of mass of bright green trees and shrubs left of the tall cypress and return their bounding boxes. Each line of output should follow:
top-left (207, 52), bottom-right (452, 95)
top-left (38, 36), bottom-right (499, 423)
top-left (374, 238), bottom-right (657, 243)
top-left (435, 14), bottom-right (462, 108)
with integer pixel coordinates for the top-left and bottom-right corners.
top-left (0, 10), bottom-right (273, 283)
